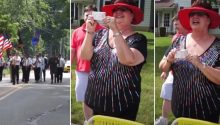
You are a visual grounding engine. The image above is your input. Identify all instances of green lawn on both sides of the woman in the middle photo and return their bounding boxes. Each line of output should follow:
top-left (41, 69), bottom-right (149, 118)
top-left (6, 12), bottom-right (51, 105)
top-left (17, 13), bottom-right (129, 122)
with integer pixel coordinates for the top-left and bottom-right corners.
top-left (71, 32), bottom-right (154, 125)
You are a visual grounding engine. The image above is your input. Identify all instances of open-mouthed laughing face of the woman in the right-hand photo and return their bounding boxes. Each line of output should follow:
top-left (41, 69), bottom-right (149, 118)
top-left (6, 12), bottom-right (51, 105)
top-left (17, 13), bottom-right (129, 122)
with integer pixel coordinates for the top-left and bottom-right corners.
top-left (189, 11), bottom-right (210, 30)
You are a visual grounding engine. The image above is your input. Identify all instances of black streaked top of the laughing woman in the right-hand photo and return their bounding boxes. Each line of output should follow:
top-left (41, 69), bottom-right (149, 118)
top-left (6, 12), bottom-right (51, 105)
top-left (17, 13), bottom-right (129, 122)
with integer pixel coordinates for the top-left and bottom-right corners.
top-left (172, 36), bottom-right (220, 122)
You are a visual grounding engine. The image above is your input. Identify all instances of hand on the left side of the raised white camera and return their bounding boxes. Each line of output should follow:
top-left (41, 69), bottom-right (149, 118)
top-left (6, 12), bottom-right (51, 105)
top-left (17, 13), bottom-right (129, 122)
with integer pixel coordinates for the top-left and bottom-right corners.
top-left (86, 15), bottom-right (97, 33)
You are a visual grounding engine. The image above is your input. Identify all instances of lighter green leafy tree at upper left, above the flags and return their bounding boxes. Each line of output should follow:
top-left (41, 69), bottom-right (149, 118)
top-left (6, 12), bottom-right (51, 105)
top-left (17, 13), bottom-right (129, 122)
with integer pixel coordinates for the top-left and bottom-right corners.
top-left (0, 0), bottom-right (49, 54)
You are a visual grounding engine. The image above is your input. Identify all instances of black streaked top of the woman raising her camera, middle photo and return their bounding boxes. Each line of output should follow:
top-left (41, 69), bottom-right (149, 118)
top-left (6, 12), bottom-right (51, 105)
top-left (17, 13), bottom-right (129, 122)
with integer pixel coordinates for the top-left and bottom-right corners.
top-left (85, 30), bottom-right (147, 113)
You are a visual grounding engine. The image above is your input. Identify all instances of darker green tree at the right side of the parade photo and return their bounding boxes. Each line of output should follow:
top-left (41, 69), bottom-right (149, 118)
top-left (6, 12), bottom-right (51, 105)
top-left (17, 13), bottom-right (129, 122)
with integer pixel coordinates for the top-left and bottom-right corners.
top-left (42, 0), bottom-right (70, 55)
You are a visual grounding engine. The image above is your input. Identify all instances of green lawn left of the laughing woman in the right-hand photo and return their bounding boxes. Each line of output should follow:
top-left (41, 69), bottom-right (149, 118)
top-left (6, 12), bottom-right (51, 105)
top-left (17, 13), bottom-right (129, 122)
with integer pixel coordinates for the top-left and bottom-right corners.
top-left (155, 37), bottom-right (174, 123)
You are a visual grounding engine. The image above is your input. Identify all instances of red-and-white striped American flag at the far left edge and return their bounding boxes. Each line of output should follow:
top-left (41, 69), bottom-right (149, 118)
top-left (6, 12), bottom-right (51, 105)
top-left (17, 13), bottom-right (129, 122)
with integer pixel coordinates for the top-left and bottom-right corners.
top-left (0, 35), bottom-right (12, 58)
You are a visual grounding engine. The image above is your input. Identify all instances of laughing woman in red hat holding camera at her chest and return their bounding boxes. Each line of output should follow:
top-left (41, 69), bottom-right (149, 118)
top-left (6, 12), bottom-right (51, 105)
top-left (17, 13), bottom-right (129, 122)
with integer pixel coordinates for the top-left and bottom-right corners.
top-left (160, 1), bottom-right (220, 123)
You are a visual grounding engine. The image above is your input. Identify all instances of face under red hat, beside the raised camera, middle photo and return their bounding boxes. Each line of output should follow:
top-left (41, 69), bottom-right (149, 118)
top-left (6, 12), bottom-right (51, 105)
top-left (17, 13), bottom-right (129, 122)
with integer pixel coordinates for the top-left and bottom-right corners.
top-left (112, 6), bottom-right (134, 26)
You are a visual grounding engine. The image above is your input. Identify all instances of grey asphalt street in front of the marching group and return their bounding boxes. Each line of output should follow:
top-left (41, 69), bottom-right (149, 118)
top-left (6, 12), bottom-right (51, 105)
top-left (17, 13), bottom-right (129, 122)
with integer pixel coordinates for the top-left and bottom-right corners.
top-left (0, 70), bottom-right (70, 125)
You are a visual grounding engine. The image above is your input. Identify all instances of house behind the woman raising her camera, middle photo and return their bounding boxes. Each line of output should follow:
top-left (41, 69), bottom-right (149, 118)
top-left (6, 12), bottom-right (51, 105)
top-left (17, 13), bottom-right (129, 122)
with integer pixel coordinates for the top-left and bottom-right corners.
top-left (71, 0), bottom-right (154, 31)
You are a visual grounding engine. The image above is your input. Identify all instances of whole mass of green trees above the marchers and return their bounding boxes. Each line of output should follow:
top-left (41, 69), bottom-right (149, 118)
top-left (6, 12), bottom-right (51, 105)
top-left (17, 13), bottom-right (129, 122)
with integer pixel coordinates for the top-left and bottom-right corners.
top-left (0, 0), bottom-right (70, 58)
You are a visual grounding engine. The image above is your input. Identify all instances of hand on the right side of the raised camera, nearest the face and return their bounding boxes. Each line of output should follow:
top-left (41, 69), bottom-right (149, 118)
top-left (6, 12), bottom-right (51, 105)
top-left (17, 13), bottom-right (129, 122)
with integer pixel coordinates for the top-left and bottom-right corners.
top-left (103, 16), bottom-right (118, 31)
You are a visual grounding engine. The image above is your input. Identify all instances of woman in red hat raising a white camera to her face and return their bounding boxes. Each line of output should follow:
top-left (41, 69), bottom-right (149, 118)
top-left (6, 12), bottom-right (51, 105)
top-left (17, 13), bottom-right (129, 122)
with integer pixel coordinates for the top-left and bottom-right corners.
top-left (80, 0), bottom-right (147, 120)
